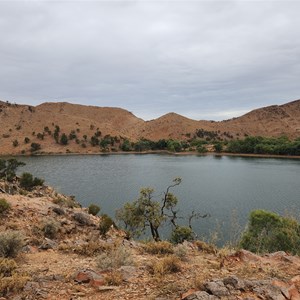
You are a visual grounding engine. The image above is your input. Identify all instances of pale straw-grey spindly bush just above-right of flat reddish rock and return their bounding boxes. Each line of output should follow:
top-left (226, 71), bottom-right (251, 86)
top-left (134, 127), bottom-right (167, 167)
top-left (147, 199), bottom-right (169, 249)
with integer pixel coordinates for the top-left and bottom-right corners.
top-left (97, 247), bottom-right (133, 270)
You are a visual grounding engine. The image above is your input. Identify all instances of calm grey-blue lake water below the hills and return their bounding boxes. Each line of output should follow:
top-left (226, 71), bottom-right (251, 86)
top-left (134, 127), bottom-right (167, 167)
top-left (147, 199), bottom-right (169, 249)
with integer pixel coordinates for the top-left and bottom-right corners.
top-left (18, 154), bottom-right (300, 241)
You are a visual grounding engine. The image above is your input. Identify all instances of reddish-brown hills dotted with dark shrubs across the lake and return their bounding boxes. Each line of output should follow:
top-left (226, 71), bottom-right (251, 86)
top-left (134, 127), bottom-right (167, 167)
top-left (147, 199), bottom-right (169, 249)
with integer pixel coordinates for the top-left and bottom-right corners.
top-left (0, 100), bottom-right (300, 154)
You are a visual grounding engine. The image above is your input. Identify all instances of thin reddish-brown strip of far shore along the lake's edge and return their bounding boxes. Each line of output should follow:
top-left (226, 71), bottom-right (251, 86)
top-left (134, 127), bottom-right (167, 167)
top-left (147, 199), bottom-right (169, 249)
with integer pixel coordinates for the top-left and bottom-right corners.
top-left (0, 150), bottom-right (300, 159)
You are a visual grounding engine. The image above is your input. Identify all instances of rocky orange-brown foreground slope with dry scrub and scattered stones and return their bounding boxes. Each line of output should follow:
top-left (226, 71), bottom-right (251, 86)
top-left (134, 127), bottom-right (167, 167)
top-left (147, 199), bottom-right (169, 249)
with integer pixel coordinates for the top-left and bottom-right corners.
top-left (0, 181), bottom-right (300, 300)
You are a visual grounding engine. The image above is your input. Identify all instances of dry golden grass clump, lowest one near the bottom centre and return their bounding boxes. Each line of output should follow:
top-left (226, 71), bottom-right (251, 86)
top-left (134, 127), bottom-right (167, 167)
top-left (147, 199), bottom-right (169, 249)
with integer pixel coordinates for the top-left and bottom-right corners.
top-left (150, 256), bottom-right (181, 276)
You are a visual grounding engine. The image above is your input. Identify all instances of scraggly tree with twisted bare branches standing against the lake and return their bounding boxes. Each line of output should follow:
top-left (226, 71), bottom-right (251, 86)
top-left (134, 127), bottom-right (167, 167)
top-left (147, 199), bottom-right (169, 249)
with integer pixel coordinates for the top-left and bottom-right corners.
top-left (116, 178), bottom-right (208, 241)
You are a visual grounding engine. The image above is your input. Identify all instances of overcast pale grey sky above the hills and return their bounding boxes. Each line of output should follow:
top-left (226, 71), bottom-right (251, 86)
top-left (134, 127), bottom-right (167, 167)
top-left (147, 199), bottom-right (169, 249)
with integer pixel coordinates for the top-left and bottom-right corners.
top-left (0, 0), bottom-right (300, 120)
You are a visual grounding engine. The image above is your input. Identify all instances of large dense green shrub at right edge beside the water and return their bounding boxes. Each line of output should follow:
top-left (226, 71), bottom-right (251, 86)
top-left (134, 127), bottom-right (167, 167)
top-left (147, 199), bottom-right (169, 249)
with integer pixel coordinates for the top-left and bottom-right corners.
top-left (240, 210), bottom-right (300, 254)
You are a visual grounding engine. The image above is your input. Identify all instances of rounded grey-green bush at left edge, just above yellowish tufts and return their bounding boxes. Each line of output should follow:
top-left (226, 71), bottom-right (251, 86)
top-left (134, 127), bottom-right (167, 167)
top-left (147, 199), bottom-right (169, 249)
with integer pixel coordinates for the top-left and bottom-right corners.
top-left (0, 231), bottom-right (23, 257)
